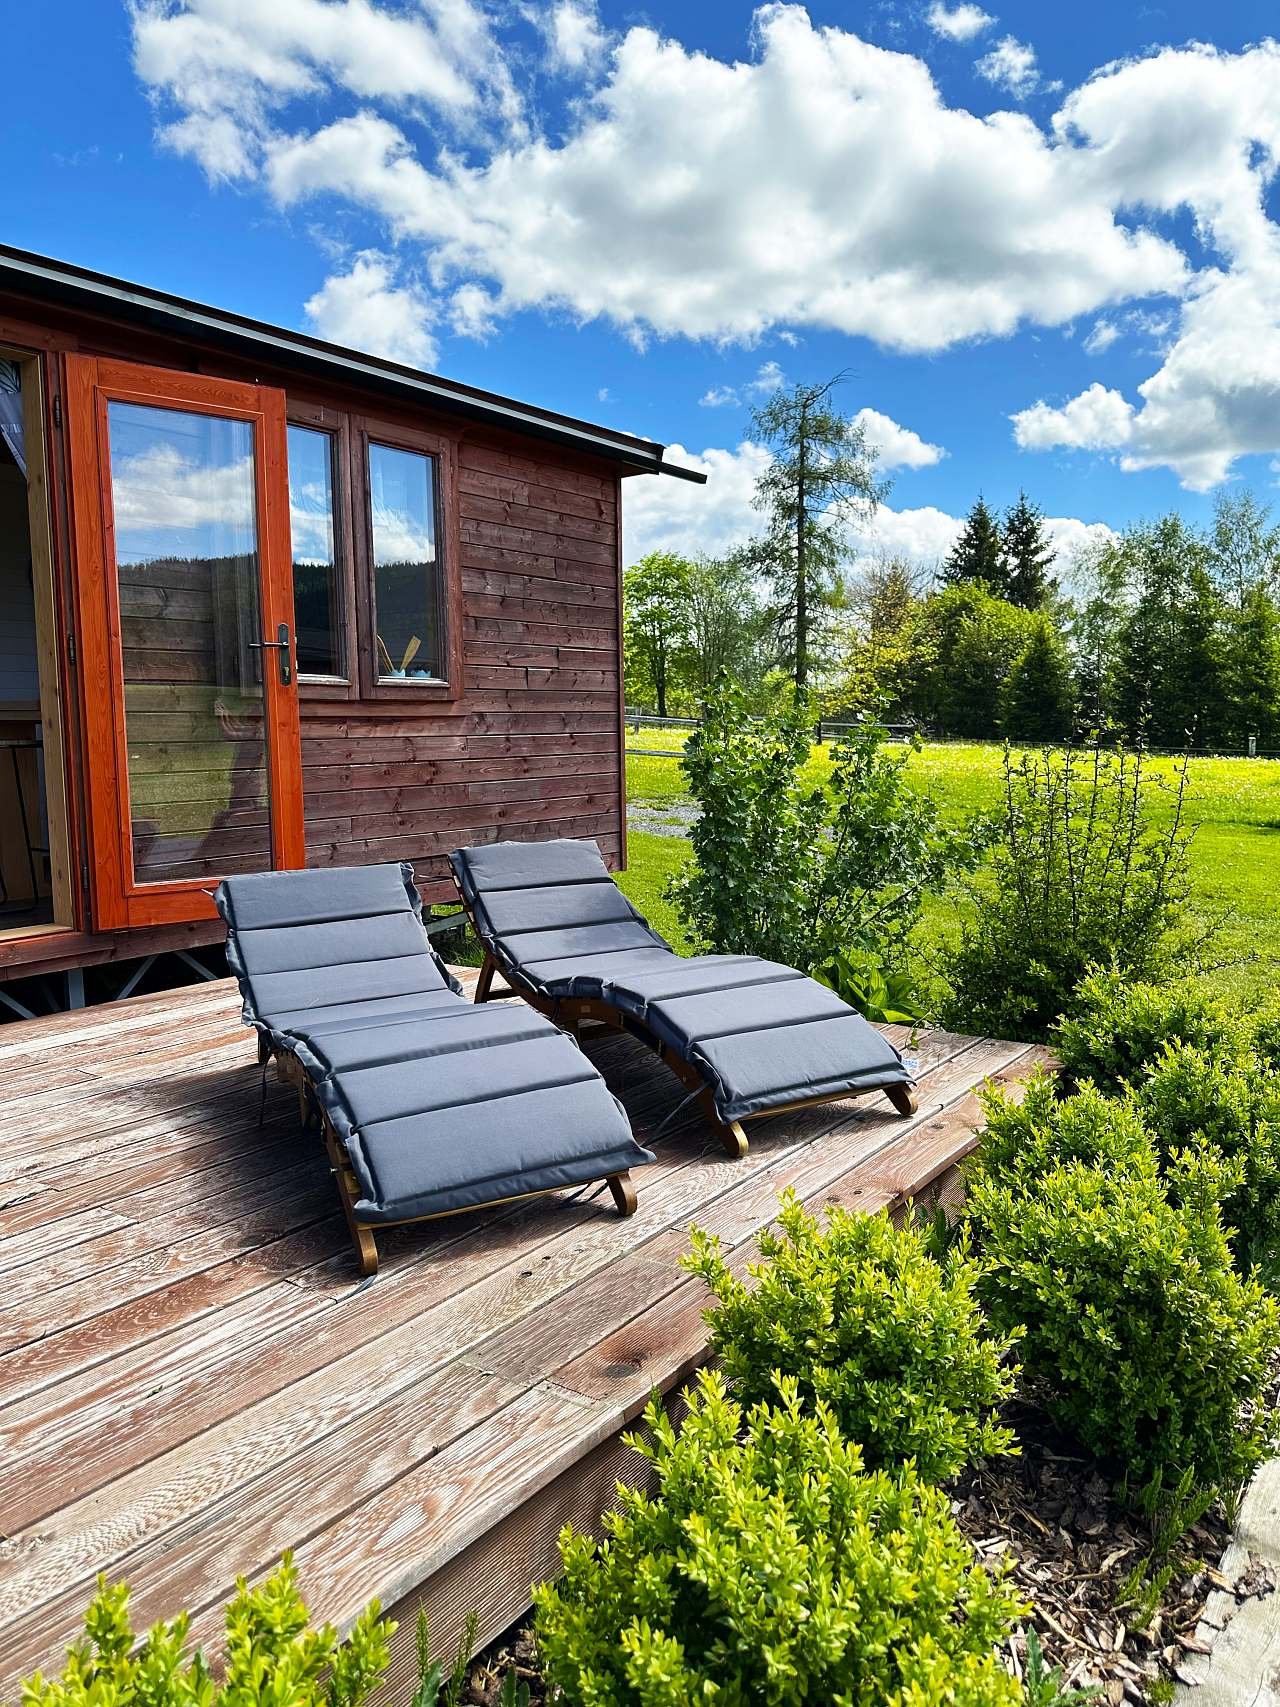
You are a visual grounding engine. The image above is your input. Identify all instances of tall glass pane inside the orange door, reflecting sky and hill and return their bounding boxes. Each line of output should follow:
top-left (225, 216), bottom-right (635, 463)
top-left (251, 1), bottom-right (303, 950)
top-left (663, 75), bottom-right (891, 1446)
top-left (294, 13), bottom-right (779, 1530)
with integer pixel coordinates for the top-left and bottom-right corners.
top-left (108, 399), bottom-right (271, 883)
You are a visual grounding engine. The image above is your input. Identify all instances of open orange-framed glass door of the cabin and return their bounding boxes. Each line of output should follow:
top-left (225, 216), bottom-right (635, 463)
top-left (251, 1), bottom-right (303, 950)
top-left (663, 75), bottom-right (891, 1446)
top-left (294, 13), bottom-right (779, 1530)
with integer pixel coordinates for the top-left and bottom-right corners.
top-left (67, 357), bottom-right (305, 929)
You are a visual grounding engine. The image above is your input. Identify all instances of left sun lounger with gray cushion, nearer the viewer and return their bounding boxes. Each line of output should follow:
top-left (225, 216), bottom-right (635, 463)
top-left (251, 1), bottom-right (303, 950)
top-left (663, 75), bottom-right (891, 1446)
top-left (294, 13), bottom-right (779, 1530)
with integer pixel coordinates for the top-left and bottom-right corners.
top-left (215, 865), bottom-right (654, 1273)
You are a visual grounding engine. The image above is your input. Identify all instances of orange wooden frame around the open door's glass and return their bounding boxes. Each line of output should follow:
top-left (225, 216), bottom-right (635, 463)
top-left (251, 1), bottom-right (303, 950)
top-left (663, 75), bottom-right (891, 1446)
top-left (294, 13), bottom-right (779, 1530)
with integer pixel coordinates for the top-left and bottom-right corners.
top-left (65, 355), bottom-right (305, 930)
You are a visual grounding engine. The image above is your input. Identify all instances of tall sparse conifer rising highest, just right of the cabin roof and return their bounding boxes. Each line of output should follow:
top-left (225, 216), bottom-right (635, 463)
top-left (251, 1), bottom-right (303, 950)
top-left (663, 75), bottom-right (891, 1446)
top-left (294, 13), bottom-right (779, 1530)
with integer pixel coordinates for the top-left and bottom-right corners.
top-left (751, 376), bottom-right (889, 691)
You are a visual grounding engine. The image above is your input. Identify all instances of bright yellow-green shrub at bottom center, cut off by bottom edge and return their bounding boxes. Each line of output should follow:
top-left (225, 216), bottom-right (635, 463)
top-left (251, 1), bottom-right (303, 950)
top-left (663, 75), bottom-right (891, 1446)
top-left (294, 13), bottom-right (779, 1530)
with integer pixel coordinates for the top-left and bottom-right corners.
top-left (534, 1372), bottom-right (1024, 1707)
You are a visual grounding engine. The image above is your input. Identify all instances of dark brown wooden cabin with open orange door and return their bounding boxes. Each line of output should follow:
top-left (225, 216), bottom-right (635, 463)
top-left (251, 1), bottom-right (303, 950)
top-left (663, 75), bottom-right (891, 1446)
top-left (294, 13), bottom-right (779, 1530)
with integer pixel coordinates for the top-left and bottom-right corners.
top-left (0, 248), bottom-right (705, 1003)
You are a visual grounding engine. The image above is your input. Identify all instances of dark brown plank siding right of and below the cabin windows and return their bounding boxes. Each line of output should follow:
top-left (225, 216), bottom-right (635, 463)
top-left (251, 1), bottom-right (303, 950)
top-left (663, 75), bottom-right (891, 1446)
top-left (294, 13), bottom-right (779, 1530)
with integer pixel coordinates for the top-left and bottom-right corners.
top-left (302, 437), bottom-right (621, 900)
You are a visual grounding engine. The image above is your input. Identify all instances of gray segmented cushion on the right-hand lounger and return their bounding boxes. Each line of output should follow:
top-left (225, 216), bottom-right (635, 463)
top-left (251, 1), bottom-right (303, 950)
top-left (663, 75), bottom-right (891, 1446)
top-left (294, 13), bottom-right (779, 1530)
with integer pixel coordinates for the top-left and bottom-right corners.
top-left (451, 842), bottom-right (911, 1120)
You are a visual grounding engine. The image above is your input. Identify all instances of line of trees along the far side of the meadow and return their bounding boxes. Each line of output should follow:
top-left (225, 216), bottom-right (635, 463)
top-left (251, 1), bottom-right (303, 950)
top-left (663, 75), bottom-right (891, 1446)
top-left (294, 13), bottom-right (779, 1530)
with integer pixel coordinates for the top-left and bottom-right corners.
top-left (623, 381), bottom-right (1280, 749)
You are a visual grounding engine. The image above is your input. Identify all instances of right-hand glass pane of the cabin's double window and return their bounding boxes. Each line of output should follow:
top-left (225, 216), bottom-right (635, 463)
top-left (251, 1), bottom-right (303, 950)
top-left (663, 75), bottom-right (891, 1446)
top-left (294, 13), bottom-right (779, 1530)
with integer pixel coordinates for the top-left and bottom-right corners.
top-left (369, 444), bottom-right (442, 681)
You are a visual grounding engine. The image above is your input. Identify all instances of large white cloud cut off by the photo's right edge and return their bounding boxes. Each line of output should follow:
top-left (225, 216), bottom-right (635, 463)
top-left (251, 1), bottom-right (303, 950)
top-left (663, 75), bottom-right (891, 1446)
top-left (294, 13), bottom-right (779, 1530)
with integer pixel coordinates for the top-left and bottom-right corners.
top-left (1014, 41), bottom-right (1280, 492)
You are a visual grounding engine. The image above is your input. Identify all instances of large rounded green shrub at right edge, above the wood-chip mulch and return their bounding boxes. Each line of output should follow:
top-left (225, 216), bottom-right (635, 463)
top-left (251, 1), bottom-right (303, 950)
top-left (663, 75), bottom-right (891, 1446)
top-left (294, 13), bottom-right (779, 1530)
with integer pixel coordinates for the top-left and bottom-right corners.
top-left (968, 1156), bottom-right (1280, 1495)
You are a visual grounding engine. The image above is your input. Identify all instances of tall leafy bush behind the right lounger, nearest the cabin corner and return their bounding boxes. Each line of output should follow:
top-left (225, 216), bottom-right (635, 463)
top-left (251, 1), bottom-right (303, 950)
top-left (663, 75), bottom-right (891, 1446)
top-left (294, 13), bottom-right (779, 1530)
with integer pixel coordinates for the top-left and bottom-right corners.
top-left (669, 679), bottom-right (983, 1005)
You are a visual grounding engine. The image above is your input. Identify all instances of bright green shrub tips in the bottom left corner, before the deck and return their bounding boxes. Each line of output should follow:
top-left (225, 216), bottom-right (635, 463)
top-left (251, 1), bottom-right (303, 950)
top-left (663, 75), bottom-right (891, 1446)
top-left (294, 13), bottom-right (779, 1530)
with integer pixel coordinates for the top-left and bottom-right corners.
top-left (22, 1555), bottom-right (396, 1707)
